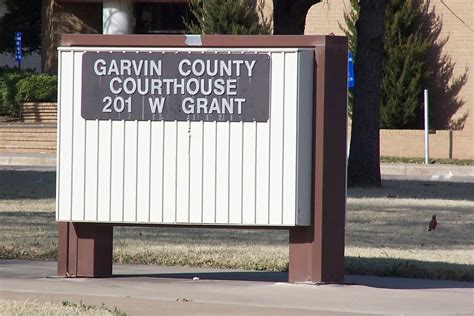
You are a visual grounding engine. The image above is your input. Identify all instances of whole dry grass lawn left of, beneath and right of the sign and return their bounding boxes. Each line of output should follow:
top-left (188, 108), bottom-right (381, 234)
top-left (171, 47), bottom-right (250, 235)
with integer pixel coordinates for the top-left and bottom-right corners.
top-left (0, 170), bottom-right (474, 281)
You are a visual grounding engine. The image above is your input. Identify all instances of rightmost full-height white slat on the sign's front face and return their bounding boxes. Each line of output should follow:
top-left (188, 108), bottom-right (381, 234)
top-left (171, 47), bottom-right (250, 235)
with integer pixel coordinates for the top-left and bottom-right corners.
top-left (282, 52), bottom-right (299, 225)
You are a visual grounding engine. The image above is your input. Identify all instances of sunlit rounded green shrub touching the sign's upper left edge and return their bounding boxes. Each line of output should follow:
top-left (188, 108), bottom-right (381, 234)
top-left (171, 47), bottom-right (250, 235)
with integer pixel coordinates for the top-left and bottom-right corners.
top-left (15, 74), bottom-right (58, 103)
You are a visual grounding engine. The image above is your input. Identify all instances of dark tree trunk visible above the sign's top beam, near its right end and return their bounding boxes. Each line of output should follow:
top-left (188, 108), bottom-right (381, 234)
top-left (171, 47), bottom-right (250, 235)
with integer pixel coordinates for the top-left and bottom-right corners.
top-left (273, 0), bottom-right (321, 35)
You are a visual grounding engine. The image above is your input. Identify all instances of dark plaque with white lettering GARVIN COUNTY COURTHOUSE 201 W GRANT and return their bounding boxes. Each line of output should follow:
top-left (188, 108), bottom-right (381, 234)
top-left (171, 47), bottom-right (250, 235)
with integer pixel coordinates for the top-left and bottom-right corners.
top-left (81, 51), bottom-right (270, 122)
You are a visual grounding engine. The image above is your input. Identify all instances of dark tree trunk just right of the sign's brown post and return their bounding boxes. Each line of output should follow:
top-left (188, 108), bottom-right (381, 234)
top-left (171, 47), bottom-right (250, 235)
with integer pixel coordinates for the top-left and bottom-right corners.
top-left (348, 0), bottom-right (385, 186)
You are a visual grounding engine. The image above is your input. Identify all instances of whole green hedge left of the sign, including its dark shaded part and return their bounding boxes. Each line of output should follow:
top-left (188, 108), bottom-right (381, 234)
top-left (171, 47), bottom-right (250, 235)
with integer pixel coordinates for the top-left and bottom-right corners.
top-left (0, 67), bottom-right (58, 117)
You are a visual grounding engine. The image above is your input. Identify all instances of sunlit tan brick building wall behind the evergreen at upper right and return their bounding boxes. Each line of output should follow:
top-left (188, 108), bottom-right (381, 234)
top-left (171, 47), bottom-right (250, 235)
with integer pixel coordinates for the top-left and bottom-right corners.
top-left (305, 0), bottom-right (474, 135)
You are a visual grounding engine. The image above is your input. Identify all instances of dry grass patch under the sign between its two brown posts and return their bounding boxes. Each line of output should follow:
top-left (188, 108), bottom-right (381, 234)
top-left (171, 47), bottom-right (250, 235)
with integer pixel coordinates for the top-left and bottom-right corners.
top-left (114, 227), bottom-right (288, 271)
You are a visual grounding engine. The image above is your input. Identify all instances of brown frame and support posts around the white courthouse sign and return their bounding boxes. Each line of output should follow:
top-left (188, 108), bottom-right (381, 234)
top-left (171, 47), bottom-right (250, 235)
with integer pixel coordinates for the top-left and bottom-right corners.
top-left (58, 35), bottom-right (347, 283)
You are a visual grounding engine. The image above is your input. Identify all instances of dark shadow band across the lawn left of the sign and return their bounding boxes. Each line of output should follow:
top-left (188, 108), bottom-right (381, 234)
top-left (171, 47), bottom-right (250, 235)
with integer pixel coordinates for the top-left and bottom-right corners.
top-left (0, 170), bottom-right (56, 200)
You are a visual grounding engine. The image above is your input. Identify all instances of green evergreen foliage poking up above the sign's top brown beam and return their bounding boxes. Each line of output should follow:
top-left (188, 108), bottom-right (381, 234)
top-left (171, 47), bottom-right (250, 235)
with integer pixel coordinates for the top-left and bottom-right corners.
top-left (185, 0), bottom-right (271, 35)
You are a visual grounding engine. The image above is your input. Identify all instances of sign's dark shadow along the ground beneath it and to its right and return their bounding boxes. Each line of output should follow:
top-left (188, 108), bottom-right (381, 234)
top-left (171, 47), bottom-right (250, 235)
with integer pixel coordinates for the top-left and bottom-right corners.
top-left (113, 257), bottom-right (474, 289)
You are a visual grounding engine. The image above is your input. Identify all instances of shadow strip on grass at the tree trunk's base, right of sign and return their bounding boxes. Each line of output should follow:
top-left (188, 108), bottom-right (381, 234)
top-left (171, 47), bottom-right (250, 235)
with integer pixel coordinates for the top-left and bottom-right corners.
top-left (347, 179), bottom-right (474, 201)
